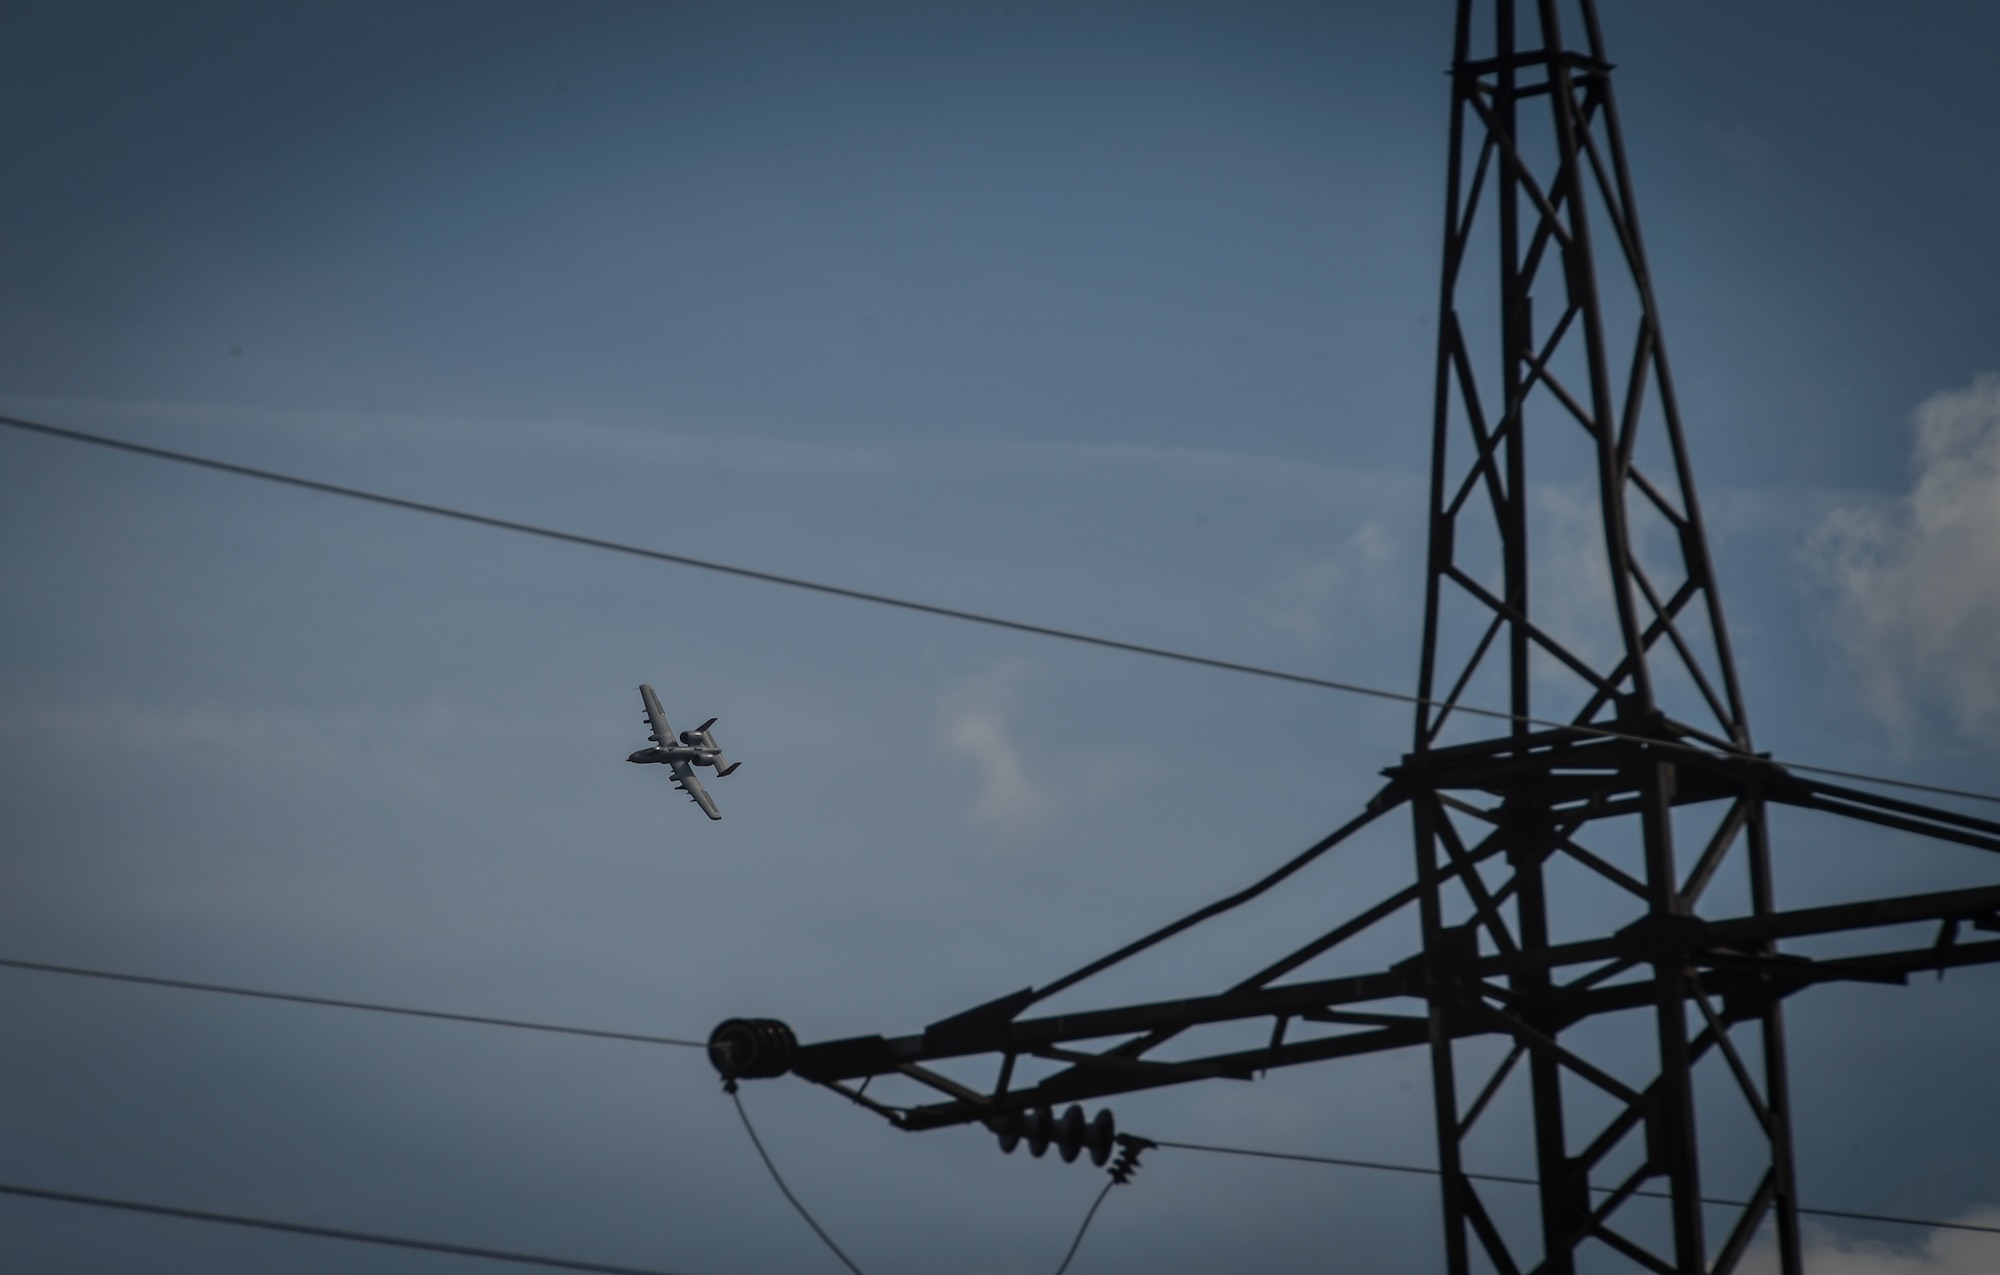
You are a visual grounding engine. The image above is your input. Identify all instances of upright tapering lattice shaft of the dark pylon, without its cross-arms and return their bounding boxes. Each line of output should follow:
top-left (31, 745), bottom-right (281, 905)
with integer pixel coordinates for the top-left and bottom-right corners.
top-left (1402, 0), bottom-right (1798, 1275)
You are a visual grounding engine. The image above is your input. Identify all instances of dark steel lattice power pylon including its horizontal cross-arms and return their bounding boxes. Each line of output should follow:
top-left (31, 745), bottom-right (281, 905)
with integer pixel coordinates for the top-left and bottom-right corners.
top-left (710, 0), bottom-right (2000, 1275)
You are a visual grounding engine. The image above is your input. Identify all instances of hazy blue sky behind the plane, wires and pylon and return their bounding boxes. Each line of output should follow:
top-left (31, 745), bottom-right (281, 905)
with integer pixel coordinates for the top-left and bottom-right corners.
top-left (0, 0), bottom-right (2000, 1275)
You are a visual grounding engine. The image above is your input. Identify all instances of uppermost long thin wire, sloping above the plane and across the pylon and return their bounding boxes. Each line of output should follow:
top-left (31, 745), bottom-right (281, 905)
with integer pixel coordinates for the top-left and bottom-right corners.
top-left (0, 416), bottom-right (2000, 819)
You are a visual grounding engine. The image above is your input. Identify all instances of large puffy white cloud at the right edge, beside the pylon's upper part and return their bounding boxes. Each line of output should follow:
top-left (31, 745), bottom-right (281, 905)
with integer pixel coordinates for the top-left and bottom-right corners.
top-left (1812, 372), bottom-right (2000, 737)
